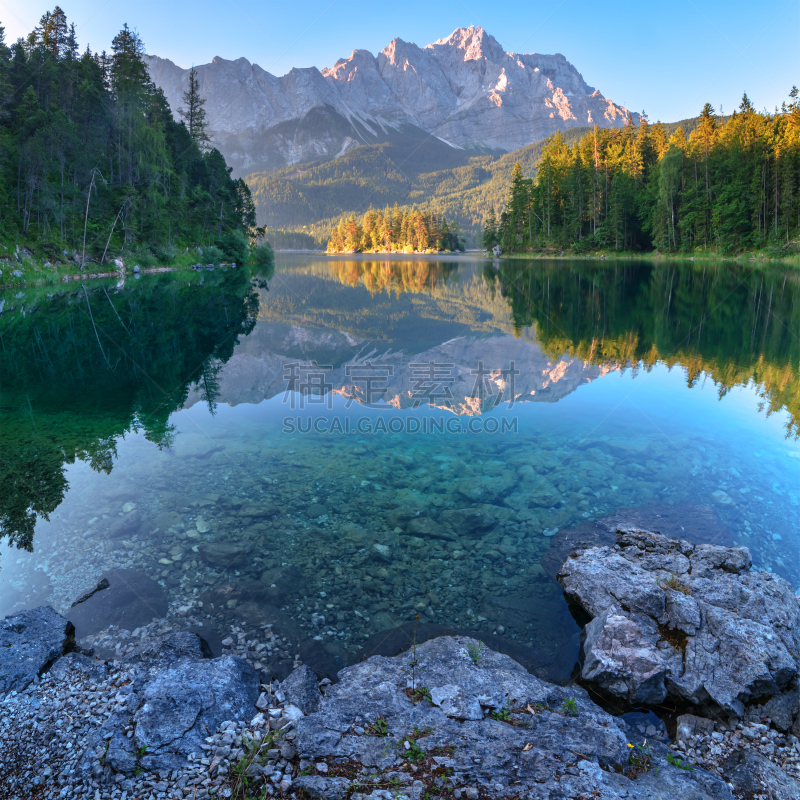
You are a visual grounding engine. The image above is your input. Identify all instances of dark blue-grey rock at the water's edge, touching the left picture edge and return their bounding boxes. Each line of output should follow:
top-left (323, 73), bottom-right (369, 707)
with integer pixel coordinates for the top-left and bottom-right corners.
top-left (0, 606), bottom-right (75, 696)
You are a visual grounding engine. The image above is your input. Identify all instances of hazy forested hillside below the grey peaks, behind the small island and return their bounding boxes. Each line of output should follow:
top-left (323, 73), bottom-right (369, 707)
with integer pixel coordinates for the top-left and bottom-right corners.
top-left (245, 119), bottom-right (708, 249)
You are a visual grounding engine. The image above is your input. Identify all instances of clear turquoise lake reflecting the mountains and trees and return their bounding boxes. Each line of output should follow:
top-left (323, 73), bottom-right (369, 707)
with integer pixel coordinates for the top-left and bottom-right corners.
top-left (0, 254), bottom-right (800, 680)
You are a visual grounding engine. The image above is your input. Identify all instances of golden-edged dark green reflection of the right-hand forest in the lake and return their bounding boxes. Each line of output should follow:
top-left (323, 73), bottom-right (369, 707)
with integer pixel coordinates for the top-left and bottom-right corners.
top-left (483, 259), bottom-right (800, 438)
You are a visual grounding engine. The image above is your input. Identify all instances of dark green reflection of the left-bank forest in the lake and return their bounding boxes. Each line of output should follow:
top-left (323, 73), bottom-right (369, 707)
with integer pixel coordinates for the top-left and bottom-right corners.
top-left (0, 270), bottom-right (258, 550)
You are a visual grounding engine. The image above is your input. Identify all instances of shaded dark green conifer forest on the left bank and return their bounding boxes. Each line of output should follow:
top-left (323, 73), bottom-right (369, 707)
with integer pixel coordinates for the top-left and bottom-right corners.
top-left (0, 6), bottom-right (255, 265)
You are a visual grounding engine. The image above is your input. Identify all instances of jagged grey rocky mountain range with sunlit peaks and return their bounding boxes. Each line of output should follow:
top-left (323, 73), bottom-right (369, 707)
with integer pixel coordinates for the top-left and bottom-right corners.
top-left (146, 27), bottom-right (629, 174)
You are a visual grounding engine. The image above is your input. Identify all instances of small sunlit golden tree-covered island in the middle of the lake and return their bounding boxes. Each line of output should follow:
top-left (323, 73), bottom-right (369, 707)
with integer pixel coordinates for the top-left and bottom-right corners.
top-left (328, 203), bottom-right (464, 253)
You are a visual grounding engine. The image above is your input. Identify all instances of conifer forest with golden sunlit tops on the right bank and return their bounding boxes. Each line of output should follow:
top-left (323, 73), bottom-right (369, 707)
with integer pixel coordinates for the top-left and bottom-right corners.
top-left (483, 93), bottom-right (800, 256)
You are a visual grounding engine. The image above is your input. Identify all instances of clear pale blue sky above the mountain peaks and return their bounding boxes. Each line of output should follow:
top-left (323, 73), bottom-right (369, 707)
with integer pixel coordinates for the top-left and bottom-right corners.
top-left (0, 0), bottom-right (800, 122)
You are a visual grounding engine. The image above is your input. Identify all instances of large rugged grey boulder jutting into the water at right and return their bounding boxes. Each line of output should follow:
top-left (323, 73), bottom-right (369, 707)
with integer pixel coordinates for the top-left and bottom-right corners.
top-left (558, 531), bottom-right (800, 717)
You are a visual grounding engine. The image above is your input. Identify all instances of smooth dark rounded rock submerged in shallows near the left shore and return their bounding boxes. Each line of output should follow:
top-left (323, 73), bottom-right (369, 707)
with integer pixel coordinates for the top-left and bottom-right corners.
top-left (67, 568), bottom-right (168, 639)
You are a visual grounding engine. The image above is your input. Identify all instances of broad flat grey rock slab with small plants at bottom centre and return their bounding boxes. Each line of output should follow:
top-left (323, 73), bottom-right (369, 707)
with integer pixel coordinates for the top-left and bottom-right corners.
top-left (295, 636), bottom-right (731, 800)
